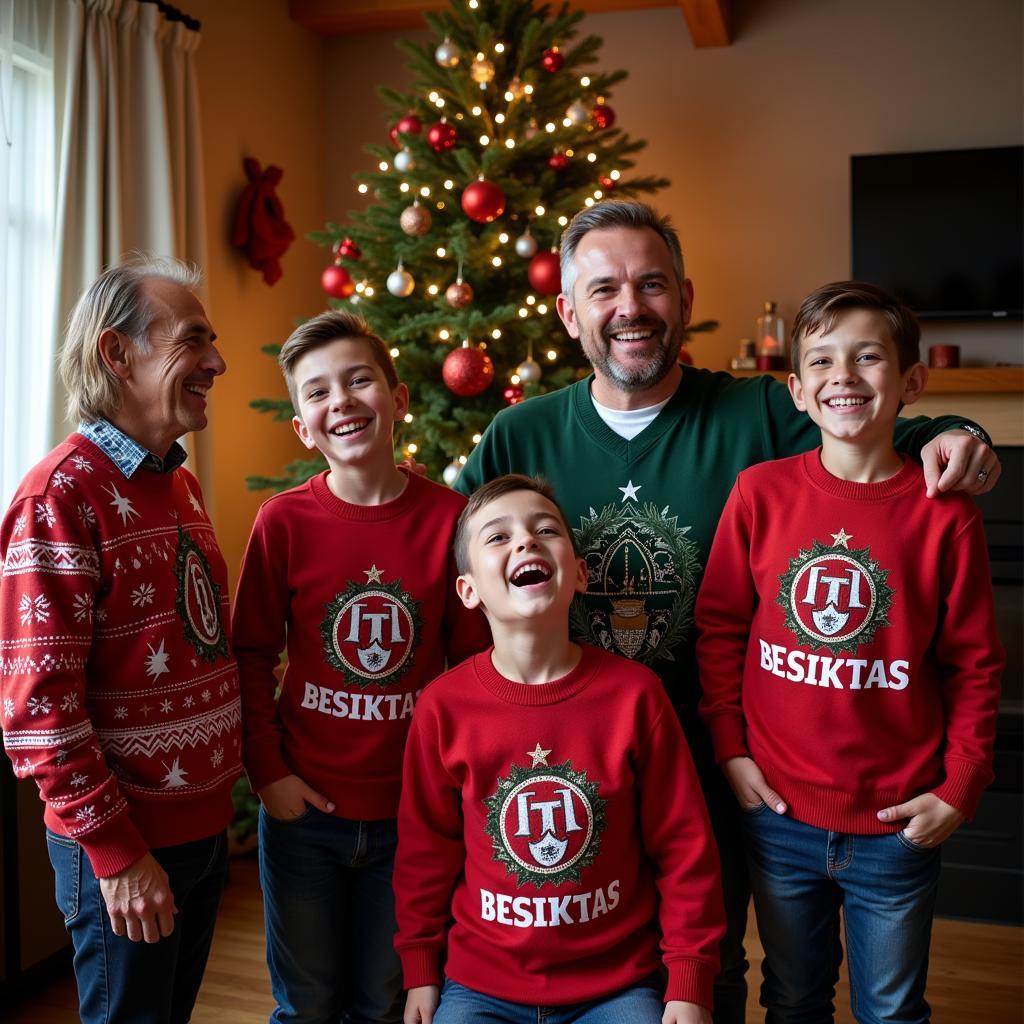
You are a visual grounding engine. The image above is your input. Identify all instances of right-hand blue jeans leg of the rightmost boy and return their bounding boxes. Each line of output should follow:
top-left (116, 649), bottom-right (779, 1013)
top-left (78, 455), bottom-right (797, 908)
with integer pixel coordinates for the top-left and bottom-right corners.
top-left (836, 833), bottom-right (941, 1024)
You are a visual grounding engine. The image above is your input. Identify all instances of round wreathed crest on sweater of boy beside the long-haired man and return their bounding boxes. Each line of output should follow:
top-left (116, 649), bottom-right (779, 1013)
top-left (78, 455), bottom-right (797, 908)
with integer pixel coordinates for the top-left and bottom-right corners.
top-left (321, 565), bottom-right (422, 686)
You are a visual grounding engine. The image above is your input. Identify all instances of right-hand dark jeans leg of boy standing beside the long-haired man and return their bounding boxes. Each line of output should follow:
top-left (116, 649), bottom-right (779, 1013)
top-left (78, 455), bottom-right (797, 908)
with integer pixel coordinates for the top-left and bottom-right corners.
top-left (345, 818), bottom-right (406, 1024)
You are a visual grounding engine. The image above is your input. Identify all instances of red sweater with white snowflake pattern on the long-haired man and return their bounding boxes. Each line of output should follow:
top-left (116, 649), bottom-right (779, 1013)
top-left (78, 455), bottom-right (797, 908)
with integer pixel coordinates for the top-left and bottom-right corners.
top-left (0, 433), bottom-right (240, 878)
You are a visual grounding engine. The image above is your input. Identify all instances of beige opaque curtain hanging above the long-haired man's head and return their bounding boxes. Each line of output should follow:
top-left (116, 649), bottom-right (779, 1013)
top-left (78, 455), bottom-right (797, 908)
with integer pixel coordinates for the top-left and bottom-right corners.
top-left (52, 0), bottom-right (206, 473)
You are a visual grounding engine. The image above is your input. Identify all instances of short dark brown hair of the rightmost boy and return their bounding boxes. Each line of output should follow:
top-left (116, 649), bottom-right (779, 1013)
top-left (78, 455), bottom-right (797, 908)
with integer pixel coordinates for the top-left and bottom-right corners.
top-left (791, 281), bottom-right (921, 377)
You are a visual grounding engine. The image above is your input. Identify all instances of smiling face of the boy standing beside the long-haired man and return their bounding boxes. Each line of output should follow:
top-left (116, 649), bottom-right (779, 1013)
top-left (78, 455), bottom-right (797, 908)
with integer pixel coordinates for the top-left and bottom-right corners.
top-left (292, 338), bottom-right (409, 469)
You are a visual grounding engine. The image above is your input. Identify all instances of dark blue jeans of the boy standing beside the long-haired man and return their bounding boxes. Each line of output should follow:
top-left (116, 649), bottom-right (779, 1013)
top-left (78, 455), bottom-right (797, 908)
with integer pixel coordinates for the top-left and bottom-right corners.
top-left (259, 807), bottom-right (404, 1024)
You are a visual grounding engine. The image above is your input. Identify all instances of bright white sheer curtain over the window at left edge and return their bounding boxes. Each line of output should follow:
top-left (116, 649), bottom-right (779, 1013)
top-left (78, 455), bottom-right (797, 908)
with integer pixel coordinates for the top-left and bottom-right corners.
top-left (0, 0), bottom-right (55, 510)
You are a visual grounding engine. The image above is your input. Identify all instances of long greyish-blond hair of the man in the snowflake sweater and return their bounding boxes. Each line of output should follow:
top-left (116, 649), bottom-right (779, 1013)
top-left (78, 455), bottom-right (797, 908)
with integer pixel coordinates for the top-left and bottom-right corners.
top-left (58, 253), bottom-right (202, 423)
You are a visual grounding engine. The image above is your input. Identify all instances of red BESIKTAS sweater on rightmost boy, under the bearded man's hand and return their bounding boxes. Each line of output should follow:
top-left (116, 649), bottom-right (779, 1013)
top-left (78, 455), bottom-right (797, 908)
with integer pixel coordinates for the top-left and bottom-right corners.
top-left (696, 450), bottom-right (1002, 835)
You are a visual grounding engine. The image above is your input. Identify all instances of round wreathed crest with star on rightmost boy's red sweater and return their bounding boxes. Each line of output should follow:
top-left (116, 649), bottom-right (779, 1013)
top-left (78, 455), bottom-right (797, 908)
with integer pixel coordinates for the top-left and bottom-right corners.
top-left (775, 527), bottom-right (895, 655)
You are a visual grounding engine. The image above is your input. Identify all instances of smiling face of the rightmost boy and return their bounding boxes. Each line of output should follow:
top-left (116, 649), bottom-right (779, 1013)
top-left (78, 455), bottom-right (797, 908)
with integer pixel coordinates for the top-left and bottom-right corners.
top-left (790, 309), bottom-right (928, 446)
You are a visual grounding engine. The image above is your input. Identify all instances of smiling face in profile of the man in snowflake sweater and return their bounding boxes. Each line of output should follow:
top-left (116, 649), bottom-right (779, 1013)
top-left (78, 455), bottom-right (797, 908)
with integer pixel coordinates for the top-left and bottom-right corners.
top-left (112, 278), bottom-right (225, 456)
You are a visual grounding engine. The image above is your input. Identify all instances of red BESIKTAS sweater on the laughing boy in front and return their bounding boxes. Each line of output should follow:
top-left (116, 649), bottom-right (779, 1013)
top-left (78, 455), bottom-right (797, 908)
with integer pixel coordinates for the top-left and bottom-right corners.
top-left (394, 646), bottom-right (724, 1007)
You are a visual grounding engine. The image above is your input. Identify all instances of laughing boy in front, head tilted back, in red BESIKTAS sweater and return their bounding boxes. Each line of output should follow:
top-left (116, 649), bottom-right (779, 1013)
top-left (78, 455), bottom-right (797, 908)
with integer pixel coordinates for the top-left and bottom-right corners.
top-left (395, 476), bottom-right (724, 1024)
